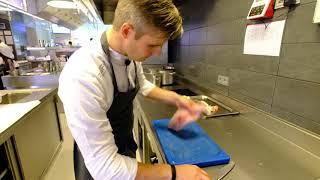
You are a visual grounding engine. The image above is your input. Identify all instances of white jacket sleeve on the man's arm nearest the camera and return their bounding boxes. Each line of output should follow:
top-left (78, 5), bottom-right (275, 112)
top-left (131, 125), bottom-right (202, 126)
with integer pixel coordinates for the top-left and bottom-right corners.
top-left (59, 51), bottom-right (137, 180)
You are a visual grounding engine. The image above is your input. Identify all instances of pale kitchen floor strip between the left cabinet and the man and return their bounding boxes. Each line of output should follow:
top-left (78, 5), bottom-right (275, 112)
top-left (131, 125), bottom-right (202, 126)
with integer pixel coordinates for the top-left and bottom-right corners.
top-left (43, 113), bottom-right (141, 180)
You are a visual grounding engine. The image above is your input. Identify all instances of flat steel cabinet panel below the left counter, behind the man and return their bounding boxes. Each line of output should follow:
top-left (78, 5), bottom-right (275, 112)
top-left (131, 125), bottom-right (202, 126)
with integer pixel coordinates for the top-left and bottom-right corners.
top-left (14, 96), bottom-right (62, 180)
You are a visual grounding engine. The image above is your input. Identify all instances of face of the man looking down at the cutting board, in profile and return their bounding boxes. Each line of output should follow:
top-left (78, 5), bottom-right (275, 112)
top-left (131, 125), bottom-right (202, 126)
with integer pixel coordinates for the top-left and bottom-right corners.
top-left (125, 25), bottom-right (167, 62)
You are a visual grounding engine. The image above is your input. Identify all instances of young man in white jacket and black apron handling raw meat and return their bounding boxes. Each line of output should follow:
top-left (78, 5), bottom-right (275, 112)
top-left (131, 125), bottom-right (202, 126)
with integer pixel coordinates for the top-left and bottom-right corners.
top-left (59, 0), bottom-right (209, 180)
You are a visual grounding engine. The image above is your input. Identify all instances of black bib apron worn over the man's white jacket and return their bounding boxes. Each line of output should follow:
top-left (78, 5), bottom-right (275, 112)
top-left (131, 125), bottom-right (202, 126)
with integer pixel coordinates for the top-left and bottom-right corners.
top-left (73, 33), bottom-right (140, 180)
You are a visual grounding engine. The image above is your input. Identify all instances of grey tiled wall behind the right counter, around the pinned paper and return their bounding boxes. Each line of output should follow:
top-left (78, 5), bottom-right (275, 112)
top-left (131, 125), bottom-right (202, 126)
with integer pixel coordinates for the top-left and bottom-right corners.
top-left (171, 0), bottom-right (320, 134)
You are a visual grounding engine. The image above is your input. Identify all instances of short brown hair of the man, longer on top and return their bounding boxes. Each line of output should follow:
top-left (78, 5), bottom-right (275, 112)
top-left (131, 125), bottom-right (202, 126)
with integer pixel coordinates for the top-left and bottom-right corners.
top-left (113, 0), bottom-right (183, 39)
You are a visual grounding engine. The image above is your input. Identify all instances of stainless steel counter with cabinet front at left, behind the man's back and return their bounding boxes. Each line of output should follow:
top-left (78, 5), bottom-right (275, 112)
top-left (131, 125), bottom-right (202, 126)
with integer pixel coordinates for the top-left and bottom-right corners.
top-left (0, 88), bottom-right (62, 179)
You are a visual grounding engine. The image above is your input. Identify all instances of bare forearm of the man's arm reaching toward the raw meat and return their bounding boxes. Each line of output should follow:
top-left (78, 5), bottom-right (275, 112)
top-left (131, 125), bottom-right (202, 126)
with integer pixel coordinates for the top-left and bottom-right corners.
top-left (147, 87), bottom-right (180, 105)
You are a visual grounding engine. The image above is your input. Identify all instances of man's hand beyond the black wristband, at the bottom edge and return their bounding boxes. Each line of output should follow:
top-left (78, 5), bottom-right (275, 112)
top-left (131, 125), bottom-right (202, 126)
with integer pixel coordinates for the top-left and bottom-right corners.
top-left (176, 165), bottom-right (210, 180)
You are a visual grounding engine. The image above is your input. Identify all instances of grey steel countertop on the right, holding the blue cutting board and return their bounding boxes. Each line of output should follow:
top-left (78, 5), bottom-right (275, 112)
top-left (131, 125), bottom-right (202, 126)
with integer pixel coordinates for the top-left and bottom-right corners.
top-left (137, 81), bottom-right (320, 180)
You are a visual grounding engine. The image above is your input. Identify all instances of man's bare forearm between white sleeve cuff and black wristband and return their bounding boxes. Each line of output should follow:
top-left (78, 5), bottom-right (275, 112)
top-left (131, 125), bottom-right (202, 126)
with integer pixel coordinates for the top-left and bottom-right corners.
top-left (135, 163), bottom-right (172, 180)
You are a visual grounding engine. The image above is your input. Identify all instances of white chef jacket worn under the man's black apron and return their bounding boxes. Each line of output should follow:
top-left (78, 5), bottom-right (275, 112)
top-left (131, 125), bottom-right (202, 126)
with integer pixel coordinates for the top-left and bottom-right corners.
top-left (58, 41), bottom-right (155, 180)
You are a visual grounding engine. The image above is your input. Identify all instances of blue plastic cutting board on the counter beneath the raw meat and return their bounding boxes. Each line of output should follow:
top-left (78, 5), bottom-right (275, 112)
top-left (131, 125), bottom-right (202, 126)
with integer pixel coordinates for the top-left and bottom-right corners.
top-left (152, 119), bottom-right (230, 167)
